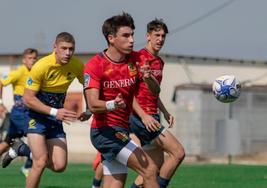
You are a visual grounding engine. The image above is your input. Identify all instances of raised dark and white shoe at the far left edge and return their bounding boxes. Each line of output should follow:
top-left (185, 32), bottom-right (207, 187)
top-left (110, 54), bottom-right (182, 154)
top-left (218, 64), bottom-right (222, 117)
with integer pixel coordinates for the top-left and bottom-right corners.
top-left (2, 140), bottom-right (25, 168)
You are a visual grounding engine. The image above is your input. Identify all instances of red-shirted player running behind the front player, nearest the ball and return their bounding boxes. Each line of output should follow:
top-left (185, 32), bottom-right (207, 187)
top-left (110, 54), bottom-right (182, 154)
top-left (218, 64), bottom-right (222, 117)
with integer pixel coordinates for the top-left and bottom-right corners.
top-left (130, 19), bottom-right (185, 188)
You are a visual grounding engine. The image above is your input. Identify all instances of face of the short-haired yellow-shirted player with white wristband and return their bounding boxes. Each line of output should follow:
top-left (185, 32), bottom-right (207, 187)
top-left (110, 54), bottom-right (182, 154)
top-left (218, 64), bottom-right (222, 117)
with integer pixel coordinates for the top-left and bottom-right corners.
top-left (54, 42), bottom-right (75, 64)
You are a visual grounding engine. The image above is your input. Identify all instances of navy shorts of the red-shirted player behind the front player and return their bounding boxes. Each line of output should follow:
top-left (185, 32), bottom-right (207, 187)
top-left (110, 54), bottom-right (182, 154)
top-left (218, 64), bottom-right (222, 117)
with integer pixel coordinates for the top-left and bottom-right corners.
top-left (130, 114), bottom-right (164, 146)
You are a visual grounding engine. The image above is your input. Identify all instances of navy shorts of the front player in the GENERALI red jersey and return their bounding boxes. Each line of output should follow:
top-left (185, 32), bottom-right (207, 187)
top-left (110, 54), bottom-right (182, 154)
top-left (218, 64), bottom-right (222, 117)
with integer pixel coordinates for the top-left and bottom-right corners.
top-left (90, 126), bottom-right (130, 161)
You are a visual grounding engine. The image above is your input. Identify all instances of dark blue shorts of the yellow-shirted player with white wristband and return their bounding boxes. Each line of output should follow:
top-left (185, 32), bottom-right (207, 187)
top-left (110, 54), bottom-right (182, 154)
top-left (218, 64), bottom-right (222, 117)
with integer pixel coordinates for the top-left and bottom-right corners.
top-left (27, 116), bottom-right (66, 139)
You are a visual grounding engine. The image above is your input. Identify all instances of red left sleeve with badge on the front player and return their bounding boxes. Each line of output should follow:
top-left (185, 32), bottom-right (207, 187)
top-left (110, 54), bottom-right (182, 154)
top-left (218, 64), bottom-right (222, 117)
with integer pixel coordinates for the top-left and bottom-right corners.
top-left (84, 59), bottom-right (103, 89)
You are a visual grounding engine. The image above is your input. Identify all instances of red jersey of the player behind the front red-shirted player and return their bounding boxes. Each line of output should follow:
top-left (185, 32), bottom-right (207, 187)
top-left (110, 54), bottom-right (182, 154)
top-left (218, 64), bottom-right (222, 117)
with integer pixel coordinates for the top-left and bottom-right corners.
top-left (135, 49), bottom-right (164, 114)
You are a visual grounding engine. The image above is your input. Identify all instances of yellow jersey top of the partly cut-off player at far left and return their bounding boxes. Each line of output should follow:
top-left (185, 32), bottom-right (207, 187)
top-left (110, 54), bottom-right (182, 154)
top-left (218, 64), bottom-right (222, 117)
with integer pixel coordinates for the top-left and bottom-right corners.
top-left (0, 65), bottom-right (30, 96)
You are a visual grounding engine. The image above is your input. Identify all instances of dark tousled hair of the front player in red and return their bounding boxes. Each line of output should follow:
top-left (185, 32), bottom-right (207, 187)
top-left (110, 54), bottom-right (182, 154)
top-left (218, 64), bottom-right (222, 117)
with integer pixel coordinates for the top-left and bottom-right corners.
top-left (102, 12), bottom-right (135, 44)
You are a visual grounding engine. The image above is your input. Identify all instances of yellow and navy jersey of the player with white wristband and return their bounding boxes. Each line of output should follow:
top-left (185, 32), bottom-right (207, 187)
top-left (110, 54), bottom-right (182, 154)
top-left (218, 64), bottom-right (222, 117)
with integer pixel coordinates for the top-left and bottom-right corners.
top-left (25, 53), bottom-right (84, 108)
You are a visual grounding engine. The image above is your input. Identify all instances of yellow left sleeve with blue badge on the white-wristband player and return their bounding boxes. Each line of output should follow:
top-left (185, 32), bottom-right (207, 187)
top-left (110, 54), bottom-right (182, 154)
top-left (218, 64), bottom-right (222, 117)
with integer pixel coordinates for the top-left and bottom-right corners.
top-left (25, 62), bottom-right (45, 91)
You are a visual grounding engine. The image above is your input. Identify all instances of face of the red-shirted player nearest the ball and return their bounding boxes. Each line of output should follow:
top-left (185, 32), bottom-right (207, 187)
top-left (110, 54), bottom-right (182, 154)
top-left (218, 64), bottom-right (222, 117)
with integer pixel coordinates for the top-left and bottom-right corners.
top-left (147, 29), bottom-right (166, 52)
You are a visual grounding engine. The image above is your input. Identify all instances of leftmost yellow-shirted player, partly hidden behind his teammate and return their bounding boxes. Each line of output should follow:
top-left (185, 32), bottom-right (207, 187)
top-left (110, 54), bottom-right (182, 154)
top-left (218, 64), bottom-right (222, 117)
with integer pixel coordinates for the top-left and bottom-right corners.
top-left (0, 48), bottom-right (38, 176)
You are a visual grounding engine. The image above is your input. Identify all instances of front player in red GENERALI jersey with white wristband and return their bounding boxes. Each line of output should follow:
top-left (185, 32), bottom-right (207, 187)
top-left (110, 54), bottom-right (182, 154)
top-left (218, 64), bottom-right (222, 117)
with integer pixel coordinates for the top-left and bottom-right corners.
top-left (84, 13), bottom-right (160, 188)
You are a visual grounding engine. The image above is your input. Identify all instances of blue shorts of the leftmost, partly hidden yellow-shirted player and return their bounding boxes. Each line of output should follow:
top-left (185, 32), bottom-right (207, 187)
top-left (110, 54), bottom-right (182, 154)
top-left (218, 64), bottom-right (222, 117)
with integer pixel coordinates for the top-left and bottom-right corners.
top-left (7, 102), bottom-right (30, 139)
